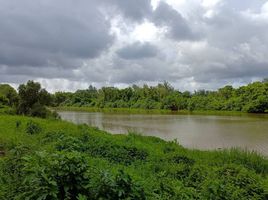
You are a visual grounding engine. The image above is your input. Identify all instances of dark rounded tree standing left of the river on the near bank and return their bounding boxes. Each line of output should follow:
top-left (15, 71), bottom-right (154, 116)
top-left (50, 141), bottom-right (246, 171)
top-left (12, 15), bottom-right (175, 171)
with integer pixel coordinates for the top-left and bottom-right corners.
top-left (17, 81), bottom-right (52, 118)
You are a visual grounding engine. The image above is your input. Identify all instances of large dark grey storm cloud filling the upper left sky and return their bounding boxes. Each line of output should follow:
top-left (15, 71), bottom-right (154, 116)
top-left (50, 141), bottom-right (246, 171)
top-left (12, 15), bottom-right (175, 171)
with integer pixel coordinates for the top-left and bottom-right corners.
top-left (0, 0), bottom-right (113, 67)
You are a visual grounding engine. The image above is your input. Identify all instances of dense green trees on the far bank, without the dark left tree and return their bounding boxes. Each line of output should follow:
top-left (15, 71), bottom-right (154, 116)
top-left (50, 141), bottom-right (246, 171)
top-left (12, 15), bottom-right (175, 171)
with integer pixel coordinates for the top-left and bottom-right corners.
top-left (53, 80), bottom-right (268, 113)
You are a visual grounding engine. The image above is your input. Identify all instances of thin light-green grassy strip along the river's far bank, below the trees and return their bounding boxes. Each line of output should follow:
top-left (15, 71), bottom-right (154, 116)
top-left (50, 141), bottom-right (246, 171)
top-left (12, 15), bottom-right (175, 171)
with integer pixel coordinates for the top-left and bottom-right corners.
top-left (54, 106), bottom-right (251, 116)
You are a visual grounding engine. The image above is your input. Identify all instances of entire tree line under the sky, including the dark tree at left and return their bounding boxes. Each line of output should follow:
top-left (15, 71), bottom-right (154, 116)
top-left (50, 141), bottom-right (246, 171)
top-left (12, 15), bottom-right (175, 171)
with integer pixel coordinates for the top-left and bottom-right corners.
top-left (0, 79), bottom-right (268, 118)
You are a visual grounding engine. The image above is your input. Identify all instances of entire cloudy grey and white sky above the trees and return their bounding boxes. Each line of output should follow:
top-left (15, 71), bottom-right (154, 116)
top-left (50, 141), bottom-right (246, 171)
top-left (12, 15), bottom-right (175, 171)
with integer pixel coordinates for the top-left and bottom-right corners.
top-left (0, 0), bottom-right (268, 92)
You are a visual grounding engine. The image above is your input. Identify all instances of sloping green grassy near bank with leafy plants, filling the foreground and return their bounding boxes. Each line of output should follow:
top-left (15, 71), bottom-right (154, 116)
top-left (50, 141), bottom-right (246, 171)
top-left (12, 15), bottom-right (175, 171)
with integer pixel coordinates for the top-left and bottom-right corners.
top-left (0, 114), bottom-right (268, 200)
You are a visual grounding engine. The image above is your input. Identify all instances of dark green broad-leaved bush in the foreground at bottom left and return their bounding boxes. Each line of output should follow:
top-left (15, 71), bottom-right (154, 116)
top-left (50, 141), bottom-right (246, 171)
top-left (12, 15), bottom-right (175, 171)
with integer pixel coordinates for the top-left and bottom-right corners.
top-left (18, 152), bottom-right (91, 200)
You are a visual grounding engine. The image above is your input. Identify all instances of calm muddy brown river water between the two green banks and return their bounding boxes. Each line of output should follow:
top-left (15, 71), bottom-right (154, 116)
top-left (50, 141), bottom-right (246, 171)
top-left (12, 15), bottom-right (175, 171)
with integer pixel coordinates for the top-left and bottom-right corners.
top-left (59, 111), bottom-right (268, 155)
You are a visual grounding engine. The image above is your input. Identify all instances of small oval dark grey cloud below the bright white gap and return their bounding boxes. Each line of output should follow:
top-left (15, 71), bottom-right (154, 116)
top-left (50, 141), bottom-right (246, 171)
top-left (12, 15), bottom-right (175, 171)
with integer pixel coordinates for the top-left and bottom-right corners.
top-left (117, 42), bottom-right (158, 60)
